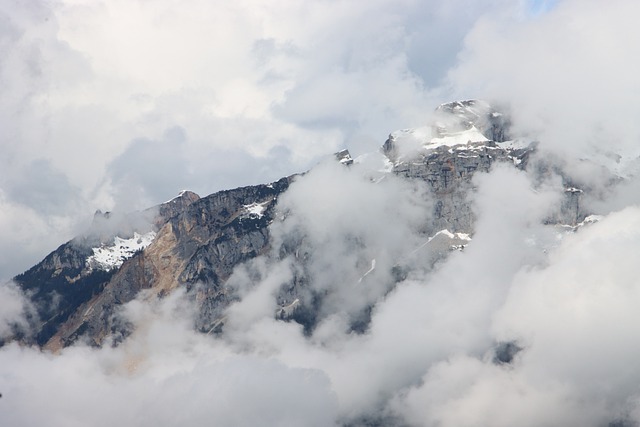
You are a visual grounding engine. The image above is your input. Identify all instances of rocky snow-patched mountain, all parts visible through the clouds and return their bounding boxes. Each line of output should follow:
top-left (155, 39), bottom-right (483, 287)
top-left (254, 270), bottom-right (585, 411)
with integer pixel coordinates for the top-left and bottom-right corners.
top-left (5, 100), bottom-right (588, 351)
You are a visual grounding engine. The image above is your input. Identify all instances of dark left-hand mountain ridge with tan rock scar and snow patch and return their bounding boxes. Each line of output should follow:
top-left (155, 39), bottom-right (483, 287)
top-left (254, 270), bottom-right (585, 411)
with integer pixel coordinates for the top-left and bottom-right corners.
top-left (14, 178), bottom-right (290, 350)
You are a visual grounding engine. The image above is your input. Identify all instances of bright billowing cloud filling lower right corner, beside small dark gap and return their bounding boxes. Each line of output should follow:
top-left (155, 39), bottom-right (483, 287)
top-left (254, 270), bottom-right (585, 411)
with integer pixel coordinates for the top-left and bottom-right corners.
top-left (393, 207), bottom-right (640, 426)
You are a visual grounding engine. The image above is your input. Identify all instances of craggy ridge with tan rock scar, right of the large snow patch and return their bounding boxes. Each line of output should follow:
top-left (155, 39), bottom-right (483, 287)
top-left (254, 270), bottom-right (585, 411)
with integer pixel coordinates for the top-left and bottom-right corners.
top-left (44, 178), bottom-right (290, 351)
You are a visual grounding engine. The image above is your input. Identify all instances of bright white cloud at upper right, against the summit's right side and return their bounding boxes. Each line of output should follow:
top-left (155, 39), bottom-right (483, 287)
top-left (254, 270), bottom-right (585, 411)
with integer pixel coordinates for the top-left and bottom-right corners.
top-left (449, 0), bottom-right (640, 176)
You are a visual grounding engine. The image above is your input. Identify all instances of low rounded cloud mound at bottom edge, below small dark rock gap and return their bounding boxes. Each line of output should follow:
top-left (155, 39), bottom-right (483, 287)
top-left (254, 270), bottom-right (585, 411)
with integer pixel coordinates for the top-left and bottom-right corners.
top-left (394, 356), bottom-right (596, 427)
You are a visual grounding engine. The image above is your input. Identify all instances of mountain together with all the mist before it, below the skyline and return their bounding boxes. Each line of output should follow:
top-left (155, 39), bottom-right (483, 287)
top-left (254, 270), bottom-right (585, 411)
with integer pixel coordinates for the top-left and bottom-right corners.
top-left (0, 96), bottom-right (640, 426)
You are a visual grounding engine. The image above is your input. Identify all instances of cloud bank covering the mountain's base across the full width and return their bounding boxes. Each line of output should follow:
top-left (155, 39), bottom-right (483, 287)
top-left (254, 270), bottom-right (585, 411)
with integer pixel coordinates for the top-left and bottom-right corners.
top-left (0, 159), bottom-right (640, 426)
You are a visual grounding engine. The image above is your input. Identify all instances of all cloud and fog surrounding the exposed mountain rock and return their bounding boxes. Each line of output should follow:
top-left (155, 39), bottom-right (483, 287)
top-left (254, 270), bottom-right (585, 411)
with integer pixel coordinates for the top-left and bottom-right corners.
top-left (0, 0), bottom-right (640, 427)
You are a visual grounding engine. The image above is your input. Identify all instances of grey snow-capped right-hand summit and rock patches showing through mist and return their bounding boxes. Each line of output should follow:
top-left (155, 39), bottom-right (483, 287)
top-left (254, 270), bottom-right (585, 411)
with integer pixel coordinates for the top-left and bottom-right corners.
top-left (276, 101), bottom-right (586, 333)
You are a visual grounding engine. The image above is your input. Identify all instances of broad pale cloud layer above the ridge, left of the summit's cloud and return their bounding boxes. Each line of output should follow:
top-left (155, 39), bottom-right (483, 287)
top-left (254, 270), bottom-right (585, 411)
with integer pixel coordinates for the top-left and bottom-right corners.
top-left (0, 0), bottom-right (524, 278)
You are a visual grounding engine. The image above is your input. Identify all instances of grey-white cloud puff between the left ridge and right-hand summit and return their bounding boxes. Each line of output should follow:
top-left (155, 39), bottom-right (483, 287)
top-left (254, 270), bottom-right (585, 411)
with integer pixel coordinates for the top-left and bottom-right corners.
top-left (245, 158), bottom-right (431, 324)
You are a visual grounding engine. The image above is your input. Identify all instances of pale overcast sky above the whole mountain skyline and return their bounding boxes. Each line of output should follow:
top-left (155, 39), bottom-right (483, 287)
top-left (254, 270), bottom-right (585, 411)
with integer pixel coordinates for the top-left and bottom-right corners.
top-left (0, 0), bottom-right (639, 278)
